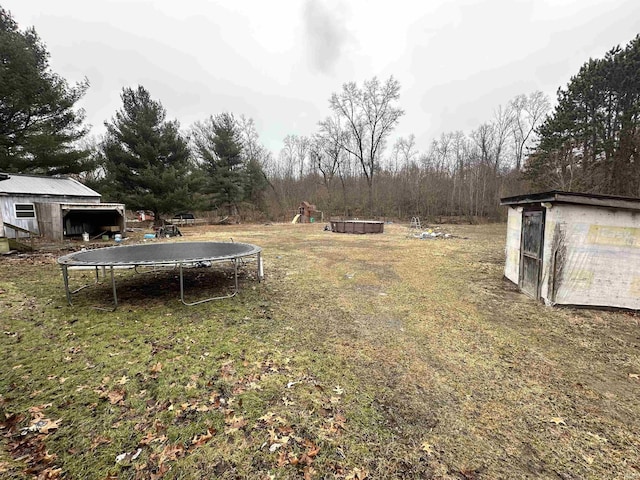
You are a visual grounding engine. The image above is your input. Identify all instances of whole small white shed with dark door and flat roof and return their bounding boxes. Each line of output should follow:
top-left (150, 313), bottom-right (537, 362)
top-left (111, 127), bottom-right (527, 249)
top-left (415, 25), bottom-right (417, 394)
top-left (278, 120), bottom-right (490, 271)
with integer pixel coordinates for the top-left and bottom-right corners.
top-left (500, 191), bottom-right (640, 310)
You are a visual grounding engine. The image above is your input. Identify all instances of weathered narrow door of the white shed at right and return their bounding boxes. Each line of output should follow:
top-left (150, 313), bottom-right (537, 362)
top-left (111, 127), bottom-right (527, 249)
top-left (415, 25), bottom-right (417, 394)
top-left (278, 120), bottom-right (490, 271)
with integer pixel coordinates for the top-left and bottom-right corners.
top-left (519, 210), bottom-right (544, 299)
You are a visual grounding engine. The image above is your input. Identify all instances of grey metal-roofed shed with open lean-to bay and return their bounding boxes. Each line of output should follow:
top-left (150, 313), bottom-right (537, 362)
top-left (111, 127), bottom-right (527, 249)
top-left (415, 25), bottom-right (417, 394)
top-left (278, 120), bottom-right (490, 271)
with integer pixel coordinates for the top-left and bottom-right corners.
top-left (0, 173), bottom-right (126, 241)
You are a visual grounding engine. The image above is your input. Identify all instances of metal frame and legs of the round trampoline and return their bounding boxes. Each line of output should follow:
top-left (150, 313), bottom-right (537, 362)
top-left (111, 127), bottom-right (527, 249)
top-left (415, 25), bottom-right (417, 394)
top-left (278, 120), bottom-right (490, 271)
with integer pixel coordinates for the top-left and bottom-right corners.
top-left (58, 242), bottom-right (264, 312)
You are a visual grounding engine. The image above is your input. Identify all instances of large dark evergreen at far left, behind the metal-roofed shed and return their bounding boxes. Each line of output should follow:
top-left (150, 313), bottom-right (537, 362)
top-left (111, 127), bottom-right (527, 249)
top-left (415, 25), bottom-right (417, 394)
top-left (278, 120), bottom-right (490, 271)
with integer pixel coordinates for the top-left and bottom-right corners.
top-left (0, 7), bottom-right (92, 175)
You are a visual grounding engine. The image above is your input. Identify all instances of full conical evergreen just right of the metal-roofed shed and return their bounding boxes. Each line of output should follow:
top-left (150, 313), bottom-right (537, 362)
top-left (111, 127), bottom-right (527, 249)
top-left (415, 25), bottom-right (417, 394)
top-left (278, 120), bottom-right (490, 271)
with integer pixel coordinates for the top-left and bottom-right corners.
top-left (102, 86), bottom-right (198, 222)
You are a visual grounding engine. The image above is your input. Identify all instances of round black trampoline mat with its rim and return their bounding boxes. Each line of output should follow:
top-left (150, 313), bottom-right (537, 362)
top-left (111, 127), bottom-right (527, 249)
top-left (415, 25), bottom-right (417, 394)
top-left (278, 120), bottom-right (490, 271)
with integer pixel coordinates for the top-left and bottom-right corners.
top-left (58, 242), bottom-right (262, 266)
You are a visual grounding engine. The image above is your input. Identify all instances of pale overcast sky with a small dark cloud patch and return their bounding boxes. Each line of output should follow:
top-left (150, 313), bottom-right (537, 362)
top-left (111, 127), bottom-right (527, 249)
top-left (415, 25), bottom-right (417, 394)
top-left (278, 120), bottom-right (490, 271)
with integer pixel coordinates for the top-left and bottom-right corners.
top-left (5, 0), bottom-right (640, 154)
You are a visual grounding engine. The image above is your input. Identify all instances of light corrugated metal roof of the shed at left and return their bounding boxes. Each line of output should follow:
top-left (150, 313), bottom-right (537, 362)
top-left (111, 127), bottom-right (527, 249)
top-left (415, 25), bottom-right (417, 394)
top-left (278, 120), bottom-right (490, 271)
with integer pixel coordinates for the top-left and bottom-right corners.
top-left (0, 173), bottom-right (100, 197)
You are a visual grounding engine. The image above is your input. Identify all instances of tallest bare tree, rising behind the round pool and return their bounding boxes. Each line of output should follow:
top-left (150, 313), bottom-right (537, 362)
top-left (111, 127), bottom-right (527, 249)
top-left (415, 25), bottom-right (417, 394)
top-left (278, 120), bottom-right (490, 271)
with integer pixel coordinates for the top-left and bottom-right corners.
top-left (329, 77), bottom-right (404, 212)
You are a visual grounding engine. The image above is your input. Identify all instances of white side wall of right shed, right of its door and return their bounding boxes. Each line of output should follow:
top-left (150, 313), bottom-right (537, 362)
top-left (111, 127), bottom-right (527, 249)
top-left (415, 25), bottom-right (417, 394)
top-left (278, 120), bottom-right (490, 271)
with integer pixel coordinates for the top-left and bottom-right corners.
top-left (541, 204), bottom-right (640, 309)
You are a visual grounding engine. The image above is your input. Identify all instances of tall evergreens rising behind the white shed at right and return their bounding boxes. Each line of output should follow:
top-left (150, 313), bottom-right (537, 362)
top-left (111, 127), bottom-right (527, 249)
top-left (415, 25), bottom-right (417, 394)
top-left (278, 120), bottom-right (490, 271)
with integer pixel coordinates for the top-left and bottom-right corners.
top-left (526, 35), bottom-right (640, 196)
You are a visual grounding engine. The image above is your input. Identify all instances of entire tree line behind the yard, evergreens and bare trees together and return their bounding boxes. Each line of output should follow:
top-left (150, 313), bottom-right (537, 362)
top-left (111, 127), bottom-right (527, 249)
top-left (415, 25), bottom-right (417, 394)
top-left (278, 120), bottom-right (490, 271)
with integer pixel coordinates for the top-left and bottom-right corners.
top-left (0, 7), bottom-right (640, 221)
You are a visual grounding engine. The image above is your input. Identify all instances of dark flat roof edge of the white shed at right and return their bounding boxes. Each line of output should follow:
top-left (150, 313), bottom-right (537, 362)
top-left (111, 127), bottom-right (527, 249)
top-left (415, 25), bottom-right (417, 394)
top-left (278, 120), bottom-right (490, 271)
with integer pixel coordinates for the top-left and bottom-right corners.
top-left (500, 190), bottom-right (640, 210)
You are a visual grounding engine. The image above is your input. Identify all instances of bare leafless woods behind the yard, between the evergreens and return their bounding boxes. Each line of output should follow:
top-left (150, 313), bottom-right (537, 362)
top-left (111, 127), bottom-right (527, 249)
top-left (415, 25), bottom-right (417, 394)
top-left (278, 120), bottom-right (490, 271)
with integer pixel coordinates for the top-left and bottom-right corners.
top-left (267, 87), bottom-right (550, 221)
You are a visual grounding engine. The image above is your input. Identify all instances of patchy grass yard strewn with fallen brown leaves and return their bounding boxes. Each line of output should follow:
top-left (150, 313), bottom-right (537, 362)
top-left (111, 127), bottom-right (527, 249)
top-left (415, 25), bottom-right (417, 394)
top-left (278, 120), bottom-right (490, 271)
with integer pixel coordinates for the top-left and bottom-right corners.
top-left (0, 224), bottom-right (640, 480)
